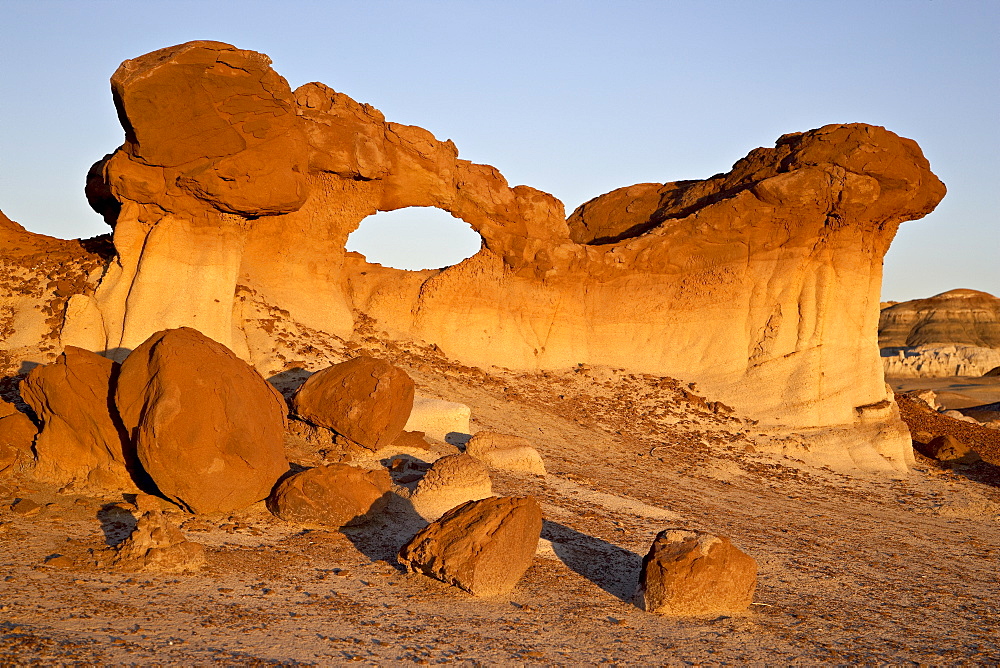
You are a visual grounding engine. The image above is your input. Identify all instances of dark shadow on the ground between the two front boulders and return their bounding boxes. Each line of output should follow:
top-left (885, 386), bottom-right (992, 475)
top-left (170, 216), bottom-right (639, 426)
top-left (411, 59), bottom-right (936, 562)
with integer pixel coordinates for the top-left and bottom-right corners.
top-left (542, 520), bottom-right (642, 603)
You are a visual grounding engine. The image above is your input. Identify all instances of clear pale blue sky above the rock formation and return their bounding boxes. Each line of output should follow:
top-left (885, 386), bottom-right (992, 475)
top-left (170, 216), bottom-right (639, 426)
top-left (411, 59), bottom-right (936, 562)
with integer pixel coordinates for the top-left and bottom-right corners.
top-left (0, 0), bottom-right (1000, 300)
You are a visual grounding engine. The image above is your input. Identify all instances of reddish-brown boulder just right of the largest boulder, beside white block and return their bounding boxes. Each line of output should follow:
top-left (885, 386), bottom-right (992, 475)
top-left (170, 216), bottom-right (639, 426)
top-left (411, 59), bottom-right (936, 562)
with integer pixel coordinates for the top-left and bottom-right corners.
top-left (293, 356), bottom-right (413, 450)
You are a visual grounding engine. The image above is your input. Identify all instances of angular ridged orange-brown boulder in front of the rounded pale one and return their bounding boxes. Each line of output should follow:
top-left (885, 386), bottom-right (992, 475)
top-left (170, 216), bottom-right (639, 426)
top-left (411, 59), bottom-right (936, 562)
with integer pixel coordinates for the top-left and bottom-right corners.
top-left (399, 497), bottom-right (542, 596)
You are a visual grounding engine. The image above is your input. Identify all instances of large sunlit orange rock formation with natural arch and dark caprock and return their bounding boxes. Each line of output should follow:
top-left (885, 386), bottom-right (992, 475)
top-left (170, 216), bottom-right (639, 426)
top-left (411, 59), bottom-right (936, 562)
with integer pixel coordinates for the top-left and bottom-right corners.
top-left (43, 42), bottom-right (944, 466)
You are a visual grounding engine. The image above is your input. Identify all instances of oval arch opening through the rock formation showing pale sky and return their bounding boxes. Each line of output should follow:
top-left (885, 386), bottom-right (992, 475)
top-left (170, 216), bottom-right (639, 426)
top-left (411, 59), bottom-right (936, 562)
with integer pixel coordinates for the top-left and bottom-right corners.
top-left (347, 206), bottom-right (483, 271)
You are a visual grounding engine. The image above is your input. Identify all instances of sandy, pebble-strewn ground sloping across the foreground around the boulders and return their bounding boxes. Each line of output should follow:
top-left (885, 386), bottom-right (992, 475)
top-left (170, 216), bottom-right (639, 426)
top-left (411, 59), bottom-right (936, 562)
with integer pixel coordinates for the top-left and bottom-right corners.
top-left (0, 350), bottom-right (1000, 665)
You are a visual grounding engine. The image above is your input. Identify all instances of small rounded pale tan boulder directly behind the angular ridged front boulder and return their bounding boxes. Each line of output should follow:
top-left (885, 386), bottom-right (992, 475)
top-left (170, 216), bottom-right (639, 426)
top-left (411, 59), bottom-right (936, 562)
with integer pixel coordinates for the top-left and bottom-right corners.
top-left (410, 454), bottom-right (493, 520)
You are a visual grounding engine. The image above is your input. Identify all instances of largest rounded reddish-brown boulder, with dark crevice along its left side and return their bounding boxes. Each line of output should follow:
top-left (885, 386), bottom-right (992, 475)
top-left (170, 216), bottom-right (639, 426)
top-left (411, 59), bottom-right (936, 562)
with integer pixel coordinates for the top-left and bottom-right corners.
top-left (115, 327), bottom-right (288, 513)
